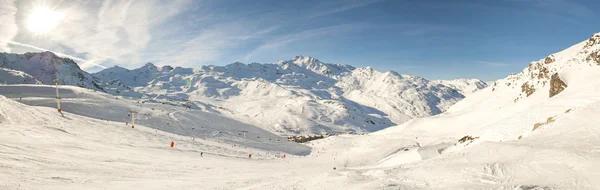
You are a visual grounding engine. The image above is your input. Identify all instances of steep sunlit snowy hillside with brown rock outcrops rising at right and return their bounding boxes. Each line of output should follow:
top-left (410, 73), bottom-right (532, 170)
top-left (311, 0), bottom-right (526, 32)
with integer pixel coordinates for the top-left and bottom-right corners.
top-left (310, 31), bottom-right (600, 189)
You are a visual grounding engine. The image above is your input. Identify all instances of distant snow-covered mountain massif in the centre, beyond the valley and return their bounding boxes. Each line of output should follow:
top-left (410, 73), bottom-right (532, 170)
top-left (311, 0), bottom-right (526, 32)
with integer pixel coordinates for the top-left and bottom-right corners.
top-left (93, 56), bottom-right (486, 134)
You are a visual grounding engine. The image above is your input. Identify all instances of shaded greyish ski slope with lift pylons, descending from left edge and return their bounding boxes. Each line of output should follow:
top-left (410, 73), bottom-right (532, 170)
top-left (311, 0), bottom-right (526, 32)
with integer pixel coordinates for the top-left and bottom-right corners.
top-left (0, 85), bottom-right (310, 155)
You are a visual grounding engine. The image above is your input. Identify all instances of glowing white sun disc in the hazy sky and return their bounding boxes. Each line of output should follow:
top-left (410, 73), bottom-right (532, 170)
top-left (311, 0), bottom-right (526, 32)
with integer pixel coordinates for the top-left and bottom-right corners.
top-left (27, 7), bottom-right (64, 35)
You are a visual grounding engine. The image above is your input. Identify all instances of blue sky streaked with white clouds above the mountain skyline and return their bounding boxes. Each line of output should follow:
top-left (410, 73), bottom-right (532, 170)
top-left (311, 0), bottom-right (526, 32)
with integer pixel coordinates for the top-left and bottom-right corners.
top-left (0, 0), bottom-right (600, 80)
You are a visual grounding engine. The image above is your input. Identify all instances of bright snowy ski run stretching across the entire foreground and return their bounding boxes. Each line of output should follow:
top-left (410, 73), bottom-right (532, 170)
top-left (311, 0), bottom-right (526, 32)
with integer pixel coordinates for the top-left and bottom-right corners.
top-left (0, 87), bottom-right (600, 189)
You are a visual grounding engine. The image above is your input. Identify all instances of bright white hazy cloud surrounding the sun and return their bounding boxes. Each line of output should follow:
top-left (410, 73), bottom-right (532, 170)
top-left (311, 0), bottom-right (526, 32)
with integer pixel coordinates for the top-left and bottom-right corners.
top-left (0, 0), bottom-right (191, 67)
